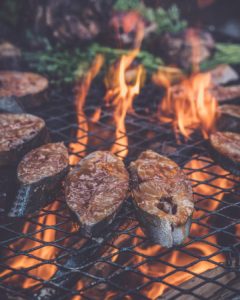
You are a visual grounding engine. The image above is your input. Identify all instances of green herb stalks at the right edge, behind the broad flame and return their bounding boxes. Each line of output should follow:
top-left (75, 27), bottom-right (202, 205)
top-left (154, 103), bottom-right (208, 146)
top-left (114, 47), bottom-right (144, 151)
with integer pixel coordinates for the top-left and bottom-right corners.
top-left (201, 43), bottom-right (240, 71)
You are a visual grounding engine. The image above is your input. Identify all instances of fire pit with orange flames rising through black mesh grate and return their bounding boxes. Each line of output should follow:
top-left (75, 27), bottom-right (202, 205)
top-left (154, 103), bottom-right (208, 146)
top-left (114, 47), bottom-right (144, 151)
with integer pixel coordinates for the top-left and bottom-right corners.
top-left (0, 1), bottom-right (240, 300)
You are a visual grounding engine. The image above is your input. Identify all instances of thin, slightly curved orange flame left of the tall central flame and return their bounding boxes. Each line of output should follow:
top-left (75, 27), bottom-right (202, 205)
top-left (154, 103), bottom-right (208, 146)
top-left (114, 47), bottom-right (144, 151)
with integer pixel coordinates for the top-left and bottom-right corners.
top-left (69, 54), bottom-right (104, 165)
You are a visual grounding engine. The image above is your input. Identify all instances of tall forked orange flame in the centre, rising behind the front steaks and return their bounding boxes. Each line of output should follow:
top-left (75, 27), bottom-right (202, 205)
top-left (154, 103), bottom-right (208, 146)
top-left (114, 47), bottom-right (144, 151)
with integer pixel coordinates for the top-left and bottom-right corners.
top-left (105, 50), bottom-right (143, 158)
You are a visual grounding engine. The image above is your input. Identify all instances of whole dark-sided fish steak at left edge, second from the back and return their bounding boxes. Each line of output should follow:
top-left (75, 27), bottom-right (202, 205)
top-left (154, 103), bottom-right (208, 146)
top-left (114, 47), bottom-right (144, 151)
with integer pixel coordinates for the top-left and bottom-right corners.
top-left (0, 114), bottom-right (48, 166)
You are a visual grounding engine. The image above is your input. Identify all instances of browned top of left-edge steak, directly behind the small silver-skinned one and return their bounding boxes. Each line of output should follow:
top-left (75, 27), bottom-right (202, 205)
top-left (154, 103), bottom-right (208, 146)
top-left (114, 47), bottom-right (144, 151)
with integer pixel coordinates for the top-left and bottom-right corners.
top-left (0, 114), bottom-right (45, 152)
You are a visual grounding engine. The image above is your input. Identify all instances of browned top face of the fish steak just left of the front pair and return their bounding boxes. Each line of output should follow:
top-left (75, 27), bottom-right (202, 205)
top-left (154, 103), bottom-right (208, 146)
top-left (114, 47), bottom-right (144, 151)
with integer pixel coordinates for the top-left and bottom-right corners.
top-left (17, 143), bottom-right (68, 184)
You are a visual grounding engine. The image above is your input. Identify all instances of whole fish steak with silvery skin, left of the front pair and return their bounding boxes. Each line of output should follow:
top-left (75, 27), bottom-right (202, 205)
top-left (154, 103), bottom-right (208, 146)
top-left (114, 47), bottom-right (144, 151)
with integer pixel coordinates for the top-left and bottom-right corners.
top-left (8, 143), bottom-right (68, 217)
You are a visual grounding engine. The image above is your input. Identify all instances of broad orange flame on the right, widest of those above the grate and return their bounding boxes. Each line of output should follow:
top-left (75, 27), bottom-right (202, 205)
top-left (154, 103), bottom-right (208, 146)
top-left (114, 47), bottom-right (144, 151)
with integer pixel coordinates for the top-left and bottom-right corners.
top-left (155, 73), bottom-right (217, 138)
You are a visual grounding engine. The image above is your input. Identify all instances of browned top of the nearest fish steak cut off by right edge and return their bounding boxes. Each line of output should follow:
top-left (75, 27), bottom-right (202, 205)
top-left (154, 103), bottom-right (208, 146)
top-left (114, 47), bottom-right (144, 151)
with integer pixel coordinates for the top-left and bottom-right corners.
top-left (210, 131), bottom-right (240, 162)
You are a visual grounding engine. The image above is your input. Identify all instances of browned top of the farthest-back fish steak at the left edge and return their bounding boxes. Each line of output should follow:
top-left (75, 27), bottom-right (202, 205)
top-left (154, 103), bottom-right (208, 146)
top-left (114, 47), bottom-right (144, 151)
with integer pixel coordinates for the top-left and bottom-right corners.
top-left (0, 71), bottom-right (48, 97)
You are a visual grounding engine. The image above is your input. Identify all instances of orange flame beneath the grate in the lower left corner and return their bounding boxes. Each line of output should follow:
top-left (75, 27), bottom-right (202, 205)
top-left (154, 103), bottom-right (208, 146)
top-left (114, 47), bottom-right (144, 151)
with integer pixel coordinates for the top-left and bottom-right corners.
top-left (0, 201), bottom-right (58, 288)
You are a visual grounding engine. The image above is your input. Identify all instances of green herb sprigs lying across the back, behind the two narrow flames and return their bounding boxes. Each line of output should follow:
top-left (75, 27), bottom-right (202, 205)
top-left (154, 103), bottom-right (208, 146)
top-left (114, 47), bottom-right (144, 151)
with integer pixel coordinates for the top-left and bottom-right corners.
top-left (24, 44), bottom-right (163, 84)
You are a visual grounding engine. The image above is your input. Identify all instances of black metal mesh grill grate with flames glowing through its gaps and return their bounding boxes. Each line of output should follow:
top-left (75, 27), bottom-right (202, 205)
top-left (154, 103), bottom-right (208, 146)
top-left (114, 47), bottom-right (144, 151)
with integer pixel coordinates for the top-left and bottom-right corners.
top-left (0, 89), bottom-right (240, 300)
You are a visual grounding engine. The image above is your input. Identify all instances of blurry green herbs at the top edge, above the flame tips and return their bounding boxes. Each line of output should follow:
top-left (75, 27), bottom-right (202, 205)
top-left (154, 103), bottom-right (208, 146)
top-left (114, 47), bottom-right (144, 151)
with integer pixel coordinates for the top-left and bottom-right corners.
top-left (114, 0), bottom-right (187, 33)
